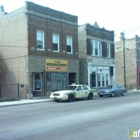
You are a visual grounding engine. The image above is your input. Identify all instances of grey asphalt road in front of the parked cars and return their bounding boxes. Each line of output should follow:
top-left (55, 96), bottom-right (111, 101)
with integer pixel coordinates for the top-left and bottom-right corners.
top-left (0, 93), bottom-right (140, 140)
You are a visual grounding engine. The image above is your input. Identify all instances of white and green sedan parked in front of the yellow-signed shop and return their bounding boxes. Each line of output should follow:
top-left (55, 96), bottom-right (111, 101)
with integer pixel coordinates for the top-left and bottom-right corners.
top-left (50, 84), bottom-right (96, 102)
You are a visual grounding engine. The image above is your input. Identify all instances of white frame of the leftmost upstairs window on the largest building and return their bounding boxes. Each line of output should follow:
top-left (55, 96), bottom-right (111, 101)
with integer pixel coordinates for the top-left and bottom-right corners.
top-left (36, 30), bottom-right (45, 50)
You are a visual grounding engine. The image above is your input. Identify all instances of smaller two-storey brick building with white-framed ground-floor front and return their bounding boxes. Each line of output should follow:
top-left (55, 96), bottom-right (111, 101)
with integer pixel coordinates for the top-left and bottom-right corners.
top-left (78, 22), bottom-right (115, 88)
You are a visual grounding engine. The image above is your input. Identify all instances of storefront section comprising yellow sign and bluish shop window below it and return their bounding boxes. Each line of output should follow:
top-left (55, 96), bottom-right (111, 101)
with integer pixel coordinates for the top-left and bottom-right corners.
top-left (45, 59), bottom-right (68, 91)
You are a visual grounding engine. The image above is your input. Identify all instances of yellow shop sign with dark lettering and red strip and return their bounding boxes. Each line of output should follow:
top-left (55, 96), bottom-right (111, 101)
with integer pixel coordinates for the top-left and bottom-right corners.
top-left (45, 59), bottom-right (68, 72)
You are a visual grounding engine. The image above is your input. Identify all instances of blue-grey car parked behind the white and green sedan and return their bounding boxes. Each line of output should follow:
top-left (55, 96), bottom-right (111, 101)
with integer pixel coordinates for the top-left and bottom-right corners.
top-left (98, 84), bottom-right (126, 97)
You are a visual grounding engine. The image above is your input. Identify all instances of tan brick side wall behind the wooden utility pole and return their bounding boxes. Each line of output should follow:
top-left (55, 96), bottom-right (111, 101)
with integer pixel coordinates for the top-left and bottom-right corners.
top-left (115, 39), bottom-right (137, 88)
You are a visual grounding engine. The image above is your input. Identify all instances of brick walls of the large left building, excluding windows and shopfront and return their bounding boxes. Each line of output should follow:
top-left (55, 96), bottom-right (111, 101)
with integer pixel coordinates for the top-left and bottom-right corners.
top-left (0, 2), bottom-right (79, 98)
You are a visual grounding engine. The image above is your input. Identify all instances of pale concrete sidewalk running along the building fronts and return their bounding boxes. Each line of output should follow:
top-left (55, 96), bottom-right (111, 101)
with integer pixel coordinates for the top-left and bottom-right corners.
top-left (0, 90), bottom-right (140, 108)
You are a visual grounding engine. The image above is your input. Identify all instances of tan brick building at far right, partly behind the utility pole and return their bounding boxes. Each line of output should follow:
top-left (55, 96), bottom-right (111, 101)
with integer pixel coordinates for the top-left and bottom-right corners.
top-left (115, 36), bottom-right (140, 88)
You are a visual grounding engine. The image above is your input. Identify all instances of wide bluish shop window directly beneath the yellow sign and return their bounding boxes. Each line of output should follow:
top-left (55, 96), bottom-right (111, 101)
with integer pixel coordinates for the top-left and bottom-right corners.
top-left (46, 72), bottom-right (67, 90)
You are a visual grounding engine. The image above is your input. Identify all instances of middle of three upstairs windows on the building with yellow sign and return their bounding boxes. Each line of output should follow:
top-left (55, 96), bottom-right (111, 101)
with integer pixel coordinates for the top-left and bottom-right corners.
top-left (52, 33), bottom-right (59, 52)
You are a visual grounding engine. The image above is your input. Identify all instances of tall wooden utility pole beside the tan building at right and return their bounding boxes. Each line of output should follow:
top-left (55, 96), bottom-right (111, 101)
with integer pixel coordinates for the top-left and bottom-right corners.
top-left (120, 32), bottom-right (126, 88)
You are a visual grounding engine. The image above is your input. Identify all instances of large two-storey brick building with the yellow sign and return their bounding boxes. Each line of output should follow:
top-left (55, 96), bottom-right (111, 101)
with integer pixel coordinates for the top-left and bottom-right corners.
top-left (0, 2), bottom-right (79, 98)
